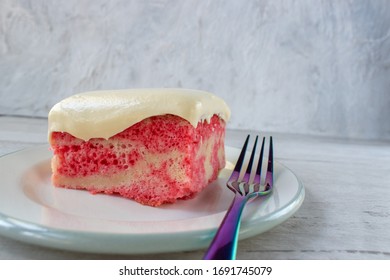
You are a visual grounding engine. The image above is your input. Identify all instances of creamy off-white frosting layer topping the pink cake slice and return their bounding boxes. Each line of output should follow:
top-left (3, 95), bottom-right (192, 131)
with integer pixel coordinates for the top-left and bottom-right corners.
top-left (49, 89), bottom-right (230, 140)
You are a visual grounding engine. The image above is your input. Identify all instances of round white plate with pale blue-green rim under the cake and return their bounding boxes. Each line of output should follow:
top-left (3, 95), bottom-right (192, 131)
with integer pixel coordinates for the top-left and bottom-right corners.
top-left (0, 144), bottom-right (304, 254)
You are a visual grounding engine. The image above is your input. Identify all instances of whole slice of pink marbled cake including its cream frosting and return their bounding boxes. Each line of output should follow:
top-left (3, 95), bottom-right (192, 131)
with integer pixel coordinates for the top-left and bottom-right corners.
top-left (49, 89), bottom-right (230, 206)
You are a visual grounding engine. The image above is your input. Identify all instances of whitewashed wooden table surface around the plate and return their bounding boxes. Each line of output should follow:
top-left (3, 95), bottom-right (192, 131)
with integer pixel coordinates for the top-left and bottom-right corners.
top-left (0, 116), bottom-right (390, 260)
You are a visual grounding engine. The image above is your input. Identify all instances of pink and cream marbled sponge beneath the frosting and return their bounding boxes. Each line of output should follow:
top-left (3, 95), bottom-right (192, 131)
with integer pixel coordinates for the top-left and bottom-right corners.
top-left (50, 114), bottom-right (229, 206)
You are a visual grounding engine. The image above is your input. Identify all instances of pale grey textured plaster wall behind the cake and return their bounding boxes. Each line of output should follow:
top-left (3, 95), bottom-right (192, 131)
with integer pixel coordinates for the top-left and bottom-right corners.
top-left (0, 0), bottom-right (390, 139)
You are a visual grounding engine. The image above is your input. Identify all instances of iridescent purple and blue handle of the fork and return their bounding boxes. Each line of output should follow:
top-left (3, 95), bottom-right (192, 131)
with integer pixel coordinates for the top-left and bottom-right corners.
top-left (203, 193), bottom-right (248, 260)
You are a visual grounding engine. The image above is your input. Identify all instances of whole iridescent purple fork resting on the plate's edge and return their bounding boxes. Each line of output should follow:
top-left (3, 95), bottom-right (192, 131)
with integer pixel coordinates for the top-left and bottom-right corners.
top-left (203, 135), bottom-right (273, 260)
